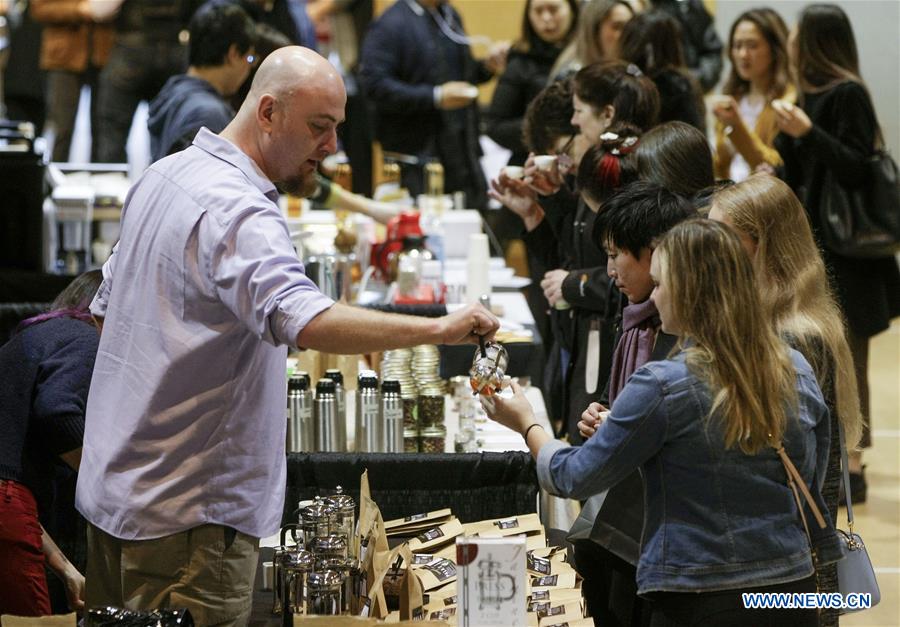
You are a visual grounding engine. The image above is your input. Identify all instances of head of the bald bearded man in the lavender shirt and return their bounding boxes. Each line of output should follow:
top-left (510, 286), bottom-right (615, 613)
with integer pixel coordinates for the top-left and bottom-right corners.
top-left (222, 46), bottom-right (347, 196)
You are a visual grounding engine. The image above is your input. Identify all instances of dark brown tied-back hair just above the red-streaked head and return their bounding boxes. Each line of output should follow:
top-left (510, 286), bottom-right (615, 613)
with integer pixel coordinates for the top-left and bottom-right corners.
top-left (575, 60), bottom-right (659, 131)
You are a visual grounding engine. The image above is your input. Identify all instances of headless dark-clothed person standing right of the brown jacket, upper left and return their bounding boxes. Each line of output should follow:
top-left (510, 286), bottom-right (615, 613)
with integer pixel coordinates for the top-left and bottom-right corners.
top-left (93, 0), bottom-right (203, 163)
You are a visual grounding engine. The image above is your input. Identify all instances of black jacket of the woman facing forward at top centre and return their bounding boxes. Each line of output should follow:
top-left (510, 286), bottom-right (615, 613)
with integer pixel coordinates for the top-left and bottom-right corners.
top-left (486, 42), bottom-right (560, 165)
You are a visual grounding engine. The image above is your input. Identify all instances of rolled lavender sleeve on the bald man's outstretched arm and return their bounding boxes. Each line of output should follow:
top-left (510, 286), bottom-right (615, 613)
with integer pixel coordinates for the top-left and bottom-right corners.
top-left (212, 208), bottom-right (334, 347)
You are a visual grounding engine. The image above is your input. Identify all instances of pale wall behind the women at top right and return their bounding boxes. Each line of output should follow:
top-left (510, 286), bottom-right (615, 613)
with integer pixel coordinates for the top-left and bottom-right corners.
top-left (716, 0), bottom-right (900, 159)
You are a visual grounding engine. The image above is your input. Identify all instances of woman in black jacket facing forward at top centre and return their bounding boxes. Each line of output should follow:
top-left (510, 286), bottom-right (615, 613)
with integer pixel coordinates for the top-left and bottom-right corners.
top-left (487, 0), bottom-right (578, 165)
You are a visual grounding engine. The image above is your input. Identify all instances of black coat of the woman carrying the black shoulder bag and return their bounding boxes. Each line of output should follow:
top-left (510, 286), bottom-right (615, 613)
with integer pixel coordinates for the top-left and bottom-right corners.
top-left (775, 81), bottom-right (900, 337)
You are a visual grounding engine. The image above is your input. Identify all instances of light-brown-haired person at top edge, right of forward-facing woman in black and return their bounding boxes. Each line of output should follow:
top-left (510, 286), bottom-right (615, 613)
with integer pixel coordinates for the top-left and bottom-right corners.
top-left (550, 0), bottom-right (634, 81)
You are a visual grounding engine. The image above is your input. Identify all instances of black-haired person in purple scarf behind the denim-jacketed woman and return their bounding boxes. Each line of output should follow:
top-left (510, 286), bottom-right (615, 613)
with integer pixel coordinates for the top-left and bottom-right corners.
top-left (573, 181), bottom-right (696, 626)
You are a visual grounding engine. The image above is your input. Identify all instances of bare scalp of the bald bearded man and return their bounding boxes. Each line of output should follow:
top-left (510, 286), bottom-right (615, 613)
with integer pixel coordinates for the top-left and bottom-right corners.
top-left (241, 46), bottom-right (346, 115)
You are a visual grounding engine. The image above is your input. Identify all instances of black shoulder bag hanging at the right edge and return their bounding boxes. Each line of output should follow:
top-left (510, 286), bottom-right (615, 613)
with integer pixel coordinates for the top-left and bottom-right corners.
top-left (819, 150), bottom-right (900, 259)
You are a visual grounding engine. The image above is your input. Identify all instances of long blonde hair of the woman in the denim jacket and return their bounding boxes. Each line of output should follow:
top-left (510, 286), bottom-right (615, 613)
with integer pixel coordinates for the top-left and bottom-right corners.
top-left (653, 219), bottom-right (798, 455)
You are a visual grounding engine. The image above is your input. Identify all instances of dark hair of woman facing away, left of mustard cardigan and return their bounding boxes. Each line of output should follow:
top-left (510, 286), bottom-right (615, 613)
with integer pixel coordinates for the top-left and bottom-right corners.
top-left (619, 9), bottom-right (686, 78)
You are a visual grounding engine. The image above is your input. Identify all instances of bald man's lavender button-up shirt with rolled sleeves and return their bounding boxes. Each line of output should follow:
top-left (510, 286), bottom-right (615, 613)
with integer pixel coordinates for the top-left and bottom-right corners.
top-left (76, 129), bottom-right (333, 540)
